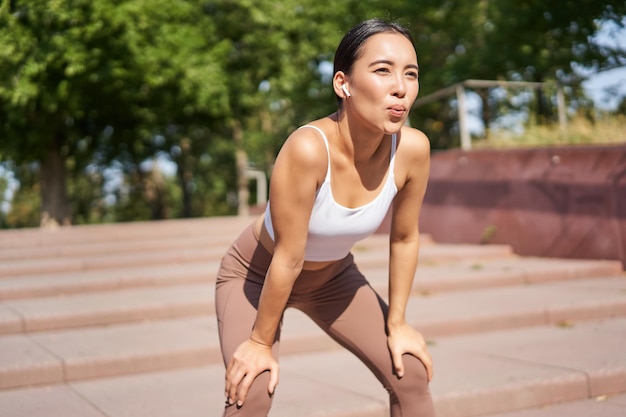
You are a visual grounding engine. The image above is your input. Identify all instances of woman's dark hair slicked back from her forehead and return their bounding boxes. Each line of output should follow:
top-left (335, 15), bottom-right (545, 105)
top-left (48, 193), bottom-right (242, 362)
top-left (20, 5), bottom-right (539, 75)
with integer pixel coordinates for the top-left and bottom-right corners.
top-left (333, 19), bottom-right (415, 102)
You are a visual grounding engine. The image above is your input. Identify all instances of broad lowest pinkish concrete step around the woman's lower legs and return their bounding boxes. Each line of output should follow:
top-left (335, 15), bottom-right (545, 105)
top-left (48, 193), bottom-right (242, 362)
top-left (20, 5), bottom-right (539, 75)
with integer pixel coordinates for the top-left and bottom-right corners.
top-left (0, 319), bottom-right (626, 417)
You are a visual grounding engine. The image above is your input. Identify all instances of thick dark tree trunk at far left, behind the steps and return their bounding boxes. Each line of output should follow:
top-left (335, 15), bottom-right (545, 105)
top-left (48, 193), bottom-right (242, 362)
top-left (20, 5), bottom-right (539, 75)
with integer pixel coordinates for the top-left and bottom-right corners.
top-left (40, 138), bottom-right (71, 227)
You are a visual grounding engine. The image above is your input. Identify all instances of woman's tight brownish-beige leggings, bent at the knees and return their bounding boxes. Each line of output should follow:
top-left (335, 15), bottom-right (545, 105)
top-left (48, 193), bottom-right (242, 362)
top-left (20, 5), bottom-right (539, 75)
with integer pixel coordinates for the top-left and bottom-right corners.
top-left (215, 226), bottom-right (435, 417)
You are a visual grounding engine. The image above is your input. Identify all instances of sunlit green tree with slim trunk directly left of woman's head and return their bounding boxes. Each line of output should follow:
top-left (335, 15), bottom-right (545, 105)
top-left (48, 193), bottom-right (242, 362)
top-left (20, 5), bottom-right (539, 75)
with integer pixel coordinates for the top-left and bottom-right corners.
top-left (206, 0), bottom-right (382, 213)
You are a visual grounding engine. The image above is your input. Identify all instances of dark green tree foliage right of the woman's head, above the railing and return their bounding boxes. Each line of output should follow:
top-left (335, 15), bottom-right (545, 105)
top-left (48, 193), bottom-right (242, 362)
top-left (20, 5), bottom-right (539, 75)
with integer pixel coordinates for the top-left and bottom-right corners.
top-left (392, 0), bottom-right (626, 147)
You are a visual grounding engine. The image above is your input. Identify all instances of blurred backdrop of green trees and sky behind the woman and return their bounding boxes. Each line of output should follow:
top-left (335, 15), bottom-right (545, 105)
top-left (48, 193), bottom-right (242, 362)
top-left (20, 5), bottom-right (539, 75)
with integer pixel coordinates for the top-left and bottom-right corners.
top-left (0, 0), bottom-right (626, 228)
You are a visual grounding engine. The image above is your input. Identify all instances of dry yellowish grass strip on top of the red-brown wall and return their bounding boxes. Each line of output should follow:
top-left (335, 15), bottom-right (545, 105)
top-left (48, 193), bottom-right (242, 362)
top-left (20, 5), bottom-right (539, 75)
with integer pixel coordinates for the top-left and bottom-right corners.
top-left (472, 114), bottom-right (626, 148)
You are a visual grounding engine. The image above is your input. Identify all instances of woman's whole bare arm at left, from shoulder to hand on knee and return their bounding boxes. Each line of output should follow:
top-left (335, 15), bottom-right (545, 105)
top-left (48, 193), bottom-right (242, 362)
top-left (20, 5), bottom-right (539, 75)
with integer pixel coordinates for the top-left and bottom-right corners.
top-left (226, 129), bottom-right (326, 405)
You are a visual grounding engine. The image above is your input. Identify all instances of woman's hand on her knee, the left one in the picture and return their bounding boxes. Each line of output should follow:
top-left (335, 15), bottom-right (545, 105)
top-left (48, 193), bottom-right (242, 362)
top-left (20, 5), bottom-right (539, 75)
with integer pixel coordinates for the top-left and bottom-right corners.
top-left (225, 339), bottom-right (278, 407)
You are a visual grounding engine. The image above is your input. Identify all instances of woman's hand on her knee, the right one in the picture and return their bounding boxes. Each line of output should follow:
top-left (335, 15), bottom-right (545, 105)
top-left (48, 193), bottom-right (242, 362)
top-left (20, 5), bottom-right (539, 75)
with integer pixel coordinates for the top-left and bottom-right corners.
top-left (387, 324), bottom-right (433, 382)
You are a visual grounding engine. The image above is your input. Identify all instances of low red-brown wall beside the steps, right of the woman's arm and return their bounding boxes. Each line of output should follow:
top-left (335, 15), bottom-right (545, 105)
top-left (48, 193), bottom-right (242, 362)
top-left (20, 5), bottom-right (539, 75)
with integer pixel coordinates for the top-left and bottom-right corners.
top-left (420, 145), bottom-right (626, 266)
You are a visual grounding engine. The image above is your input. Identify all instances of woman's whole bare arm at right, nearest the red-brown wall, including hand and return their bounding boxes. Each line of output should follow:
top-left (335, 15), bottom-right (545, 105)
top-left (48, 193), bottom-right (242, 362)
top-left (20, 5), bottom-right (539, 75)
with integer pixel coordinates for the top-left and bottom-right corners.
top-left (387, 129), bottom-right (432, 378)
